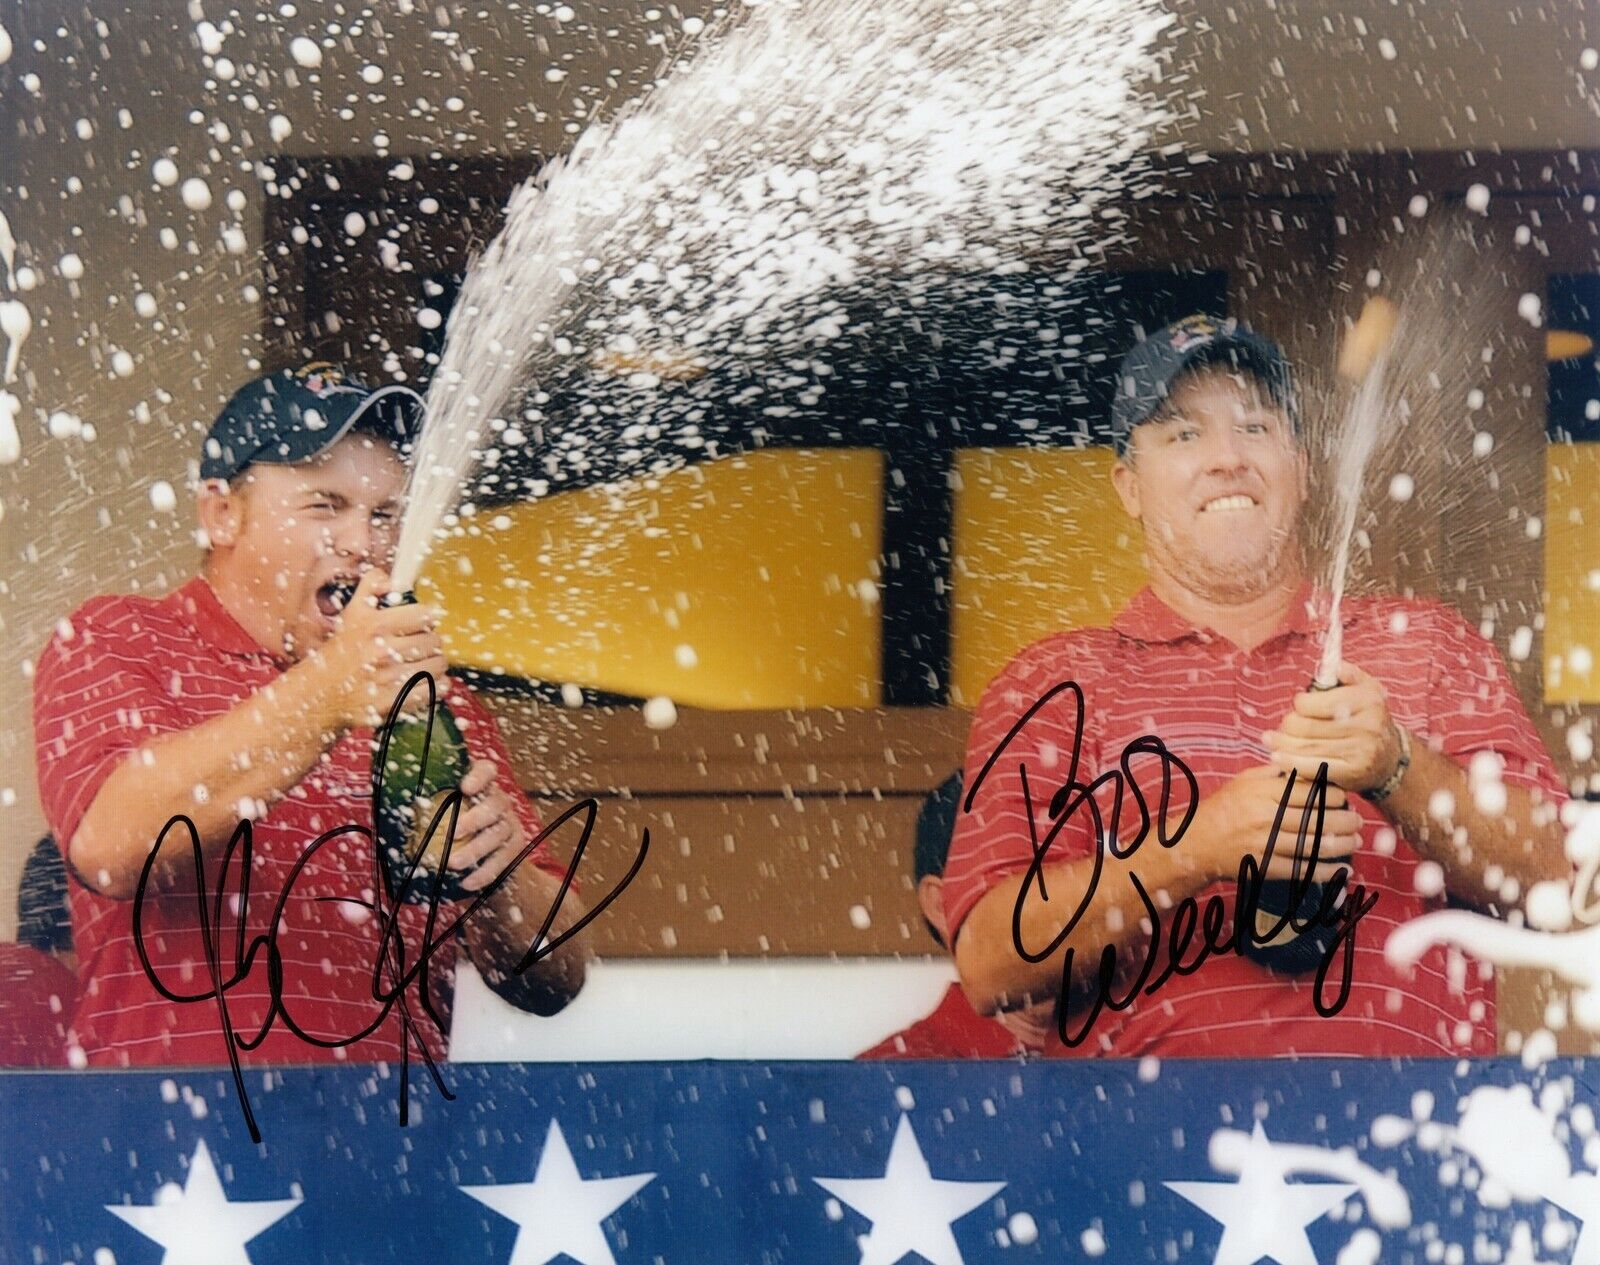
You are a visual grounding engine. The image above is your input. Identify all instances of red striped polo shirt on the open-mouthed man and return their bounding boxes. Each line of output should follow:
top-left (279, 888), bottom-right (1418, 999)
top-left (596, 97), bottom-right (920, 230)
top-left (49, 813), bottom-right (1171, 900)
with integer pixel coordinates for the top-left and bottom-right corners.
top-left (34, 577), bottom-right (562, 1067)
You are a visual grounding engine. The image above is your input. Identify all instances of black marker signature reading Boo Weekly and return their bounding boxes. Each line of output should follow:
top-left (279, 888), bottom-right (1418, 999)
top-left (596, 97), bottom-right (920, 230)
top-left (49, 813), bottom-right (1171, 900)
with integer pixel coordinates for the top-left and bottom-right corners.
top-left (963, 681), bottom-right (1378, 1048)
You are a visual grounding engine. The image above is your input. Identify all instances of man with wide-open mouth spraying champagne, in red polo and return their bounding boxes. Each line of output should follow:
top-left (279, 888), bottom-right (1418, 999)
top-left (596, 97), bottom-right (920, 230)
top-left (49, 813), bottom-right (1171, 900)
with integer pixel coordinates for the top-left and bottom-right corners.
top-left (34, 366), bottom-right (584, 1067)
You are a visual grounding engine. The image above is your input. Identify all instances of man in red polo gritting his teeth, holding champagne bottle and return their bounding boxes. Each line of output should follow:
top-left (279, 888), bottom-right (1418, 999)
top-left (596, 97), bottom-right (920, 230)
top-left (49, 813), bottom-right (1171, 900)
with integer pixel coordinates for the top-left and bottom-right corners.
top-left (944, 317), bottom-right (1570, 1057)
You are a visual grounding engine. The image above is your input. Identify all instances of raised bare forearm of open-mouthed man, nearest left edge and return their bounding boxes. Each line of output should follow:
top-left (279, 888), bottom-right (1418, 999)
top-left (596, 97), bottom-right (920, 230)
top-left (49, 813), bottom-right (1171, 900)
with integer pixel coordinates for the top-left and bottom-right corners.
top-left (67, 665), bottom-right (336, 899)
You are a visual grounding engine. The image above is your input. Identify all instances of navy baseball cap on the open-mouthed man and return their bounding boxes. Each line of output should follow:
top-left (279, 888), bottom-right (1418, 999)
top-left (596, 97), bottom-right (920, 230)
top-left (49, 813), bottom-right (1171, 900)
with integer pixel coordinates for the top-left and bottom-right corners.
top-left (200, 363), bottom-right (422, 478)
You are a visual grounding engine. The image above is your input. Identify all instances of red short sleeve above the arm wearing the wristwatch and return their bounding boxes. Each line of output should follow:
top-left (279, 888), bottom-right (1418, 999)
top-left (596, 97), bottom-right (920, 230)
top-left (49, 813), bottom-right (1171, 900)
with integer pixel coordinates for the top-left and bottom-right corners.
top-left (1429, 608), bottom-right (1568, 804)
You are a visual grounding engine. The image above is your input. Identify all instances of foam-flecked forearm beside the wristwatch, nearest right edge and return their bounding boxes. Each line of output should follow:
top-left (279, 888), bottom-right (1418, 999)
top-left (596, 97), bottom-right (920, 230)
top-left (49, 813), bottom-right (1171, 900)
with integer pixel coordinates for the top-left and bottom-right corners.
top-left (1379, 737), bottom-right (1573, 907)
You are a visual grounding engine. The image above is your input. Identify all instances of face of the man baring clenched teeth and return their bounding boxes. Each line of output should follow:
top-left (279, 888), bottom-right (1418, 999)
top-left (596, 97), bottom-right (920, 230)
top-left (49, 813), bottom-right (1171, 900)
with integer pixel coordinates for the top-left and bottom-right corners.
top-left (1112, 368), bottom-right (1307, 603)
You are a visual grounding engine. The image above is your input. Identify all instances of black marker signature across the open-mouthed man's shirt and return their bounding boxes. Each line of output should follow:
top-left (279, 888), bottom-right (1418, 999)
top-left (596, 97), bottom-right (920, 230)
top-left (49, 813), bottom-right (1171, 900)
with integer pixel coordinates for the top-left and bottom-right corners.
top-left (133, 672), bottom-right (650, 1142)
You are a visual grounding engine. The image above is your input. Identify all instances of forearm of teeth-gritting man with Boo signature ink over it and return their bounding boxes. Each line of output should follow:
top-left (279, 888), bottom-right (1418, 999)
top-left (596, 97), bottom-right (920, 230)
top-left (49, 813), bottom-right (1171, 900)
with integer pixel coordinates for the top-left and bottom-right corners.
top-left (955, 843), bottom-right (1210, 1014)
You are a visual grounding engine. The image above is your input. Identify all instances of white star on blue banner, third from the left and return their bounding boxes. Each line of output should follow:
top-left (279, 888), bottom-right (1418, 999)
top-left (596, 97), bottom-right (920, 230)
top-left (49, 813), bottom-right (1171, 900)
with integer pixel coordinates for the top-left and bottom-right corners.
top-left (811, 1115), bottom-right (1005, 1265)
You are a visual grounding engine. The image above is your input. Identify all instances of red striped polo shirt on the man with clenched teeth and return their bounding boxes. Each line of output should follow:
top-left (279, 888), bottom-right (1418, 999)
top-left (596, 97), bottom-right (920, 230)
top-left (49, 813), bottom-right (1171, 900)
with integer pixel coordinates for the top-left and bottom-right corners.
top-left (944, 585), bottom-right (1566, 1057)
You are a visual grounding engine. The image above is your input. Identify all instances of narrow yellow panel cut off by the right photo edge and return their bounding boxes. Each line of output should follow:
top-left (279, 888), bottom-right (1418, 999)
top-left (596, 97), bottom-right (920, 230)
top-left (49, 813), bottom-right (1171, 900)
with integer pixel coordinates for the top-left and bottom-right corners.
top-left (1544, 443), bottom-right (1600, 702)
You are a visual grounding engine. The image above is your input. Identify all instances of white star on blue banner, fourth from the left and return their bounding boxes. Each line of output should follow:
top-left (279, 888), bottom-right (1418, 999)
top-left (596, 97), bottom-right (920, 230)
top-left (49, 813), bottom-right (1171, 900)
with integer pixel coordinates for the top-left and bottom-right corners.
top-left (1163, 1119), bottom-right (1358, 1265)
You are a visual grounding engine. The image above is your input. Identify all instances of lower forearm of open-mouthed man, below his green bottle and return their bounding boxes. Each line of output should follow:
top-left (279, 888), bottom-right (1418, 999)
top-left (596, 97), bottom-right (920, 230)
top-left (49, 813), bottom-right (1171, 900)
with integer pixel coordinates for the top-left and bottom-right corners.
top-left (462, 862), bottom-right (589, 1016)
